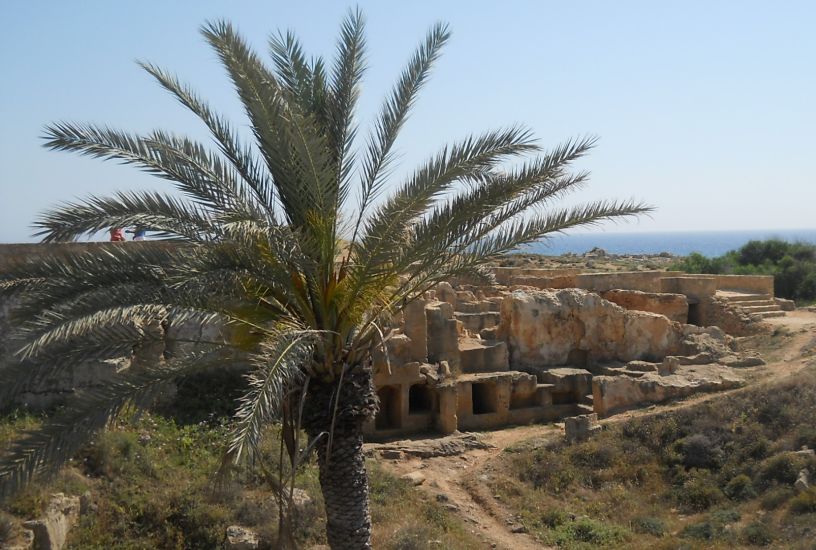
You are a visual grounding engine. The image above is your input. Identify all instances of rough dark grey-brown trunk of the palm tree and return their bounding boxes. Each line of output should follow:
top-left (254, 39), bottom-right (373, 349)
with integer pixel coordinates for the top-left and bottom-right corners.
top-left (303, 367), bottom-right (377, 550)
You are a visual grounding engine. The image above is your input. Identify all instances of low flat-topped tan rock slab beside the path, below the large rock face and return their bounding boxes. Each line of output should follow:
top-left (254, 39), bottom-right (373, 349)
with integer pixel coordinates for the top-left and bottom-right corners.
top-left (592, 364), bottom-right (743, 416)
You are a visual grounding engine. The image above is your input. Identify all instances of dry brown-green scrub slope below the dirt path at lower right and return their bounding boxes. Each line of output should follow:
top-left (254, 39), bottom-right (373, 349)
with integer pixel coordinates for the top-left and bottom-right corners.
top-left (491, 368), bottom-right (816, 548)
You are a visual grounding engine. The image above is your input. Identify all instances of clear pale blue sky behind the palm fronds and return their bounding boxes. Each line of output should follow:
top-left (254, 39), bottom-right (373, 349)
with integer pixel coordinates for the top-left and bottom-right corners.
top-left (0, 0), bottom-right (816, 242)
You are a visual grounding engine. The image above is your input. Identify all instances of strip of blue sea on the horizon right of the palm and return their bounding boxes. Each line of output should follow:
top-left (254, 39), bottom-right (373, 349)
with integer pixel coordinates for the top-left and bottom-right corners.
top-left (522, 229), bottom-right (816, 257)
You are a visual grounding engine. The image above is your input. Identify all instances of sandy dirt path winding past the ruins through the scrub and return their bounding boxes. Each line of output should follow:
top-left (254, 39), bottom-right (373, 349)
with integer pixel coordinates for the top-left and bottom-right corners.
top-left (371, 310), bottom-right (816, 550)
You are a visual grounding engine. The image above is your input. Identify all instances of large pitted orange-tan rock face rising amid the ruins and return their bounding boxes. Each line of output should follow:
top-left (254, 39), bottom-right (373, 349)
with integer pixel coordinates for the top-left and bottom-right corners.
top-left (501, 289), bottom-right (684, 368)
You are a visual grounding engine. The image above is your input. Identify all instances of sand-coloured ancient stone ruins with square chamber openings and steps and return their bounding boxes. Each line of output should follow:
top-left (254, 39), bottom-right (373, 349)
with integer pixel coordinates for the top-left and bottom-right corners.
top-left (0, 245), bottom-right (790, 440)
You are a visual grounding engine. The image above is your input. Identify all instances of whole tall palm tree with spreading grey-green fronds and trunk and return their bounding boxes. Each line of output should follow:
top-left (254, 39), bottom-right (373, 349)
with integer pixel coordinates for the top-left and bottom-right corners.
top-left (0, 11), bottom-right (649, 548)
